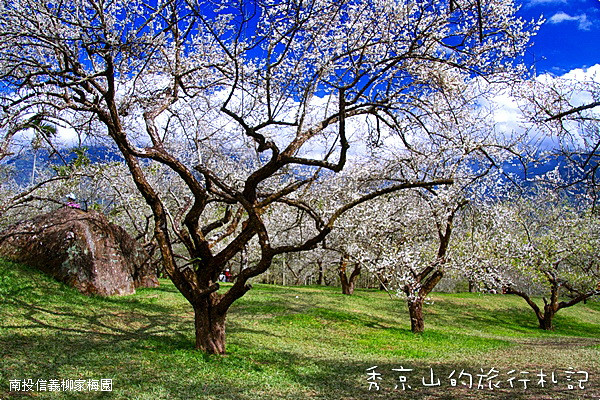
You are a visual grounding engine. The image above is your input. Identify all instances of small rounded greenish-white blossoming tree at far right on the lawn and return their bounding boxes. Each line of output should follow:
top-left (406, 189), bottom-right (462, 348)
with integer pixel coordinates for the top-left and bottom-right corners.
top-left (467, 187), bottom-right (600, 330)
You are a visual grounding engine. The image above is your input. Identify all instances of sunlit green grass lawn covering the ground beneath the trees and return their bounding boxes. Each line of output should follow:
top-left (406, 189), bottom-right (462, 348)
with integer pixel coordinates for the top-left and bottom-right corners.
top-left (0, 261), bottom-right (600, 400)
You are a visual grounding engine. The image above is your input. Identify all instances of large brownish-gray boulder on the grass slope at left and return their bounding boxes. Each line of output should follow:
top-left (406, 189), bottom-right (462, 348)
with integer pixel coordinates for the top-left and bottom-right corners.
top-left (0, 207), bottom-right (158, 296)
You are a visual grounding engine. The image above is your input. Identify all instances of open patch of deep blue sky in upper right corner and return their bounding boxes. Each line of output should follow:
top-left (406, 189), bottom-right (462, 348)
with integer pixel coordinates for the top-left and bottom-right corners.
top-left (520, 0), bottom-right (600, 75)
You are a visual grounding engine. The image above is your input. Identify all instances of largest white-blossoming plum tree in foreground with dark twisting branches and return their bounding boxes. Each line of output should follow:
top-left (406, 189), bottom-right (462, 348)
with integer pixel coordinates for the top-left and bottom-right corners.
top-left (0, 0), bottom-right (534, 353)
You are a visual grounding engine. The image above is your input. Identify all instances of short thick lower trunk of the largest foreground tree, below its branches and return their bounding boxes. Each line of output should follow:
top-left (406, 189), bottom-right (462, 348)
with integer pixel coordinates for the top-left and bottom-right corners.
top-left (194, 296), bottom-right (225, 354)
